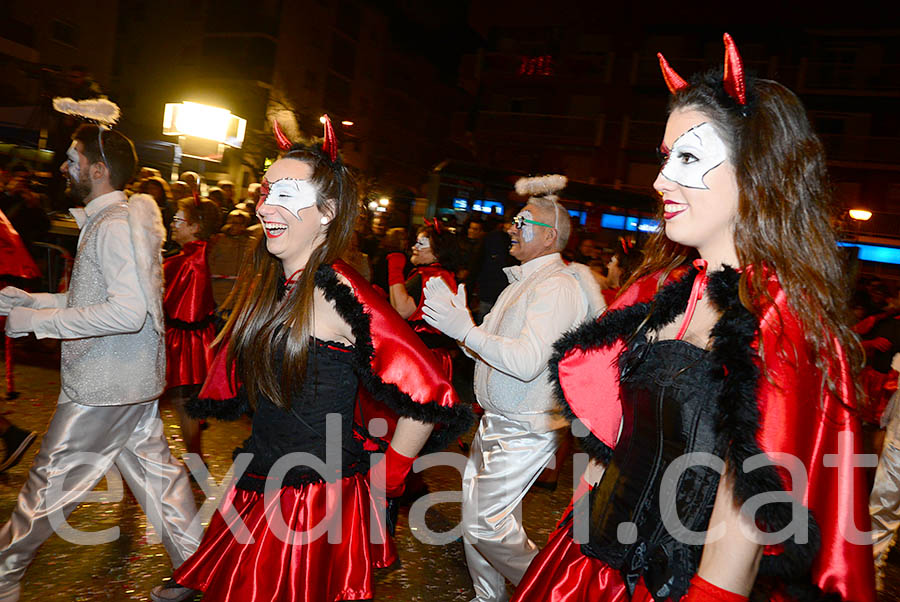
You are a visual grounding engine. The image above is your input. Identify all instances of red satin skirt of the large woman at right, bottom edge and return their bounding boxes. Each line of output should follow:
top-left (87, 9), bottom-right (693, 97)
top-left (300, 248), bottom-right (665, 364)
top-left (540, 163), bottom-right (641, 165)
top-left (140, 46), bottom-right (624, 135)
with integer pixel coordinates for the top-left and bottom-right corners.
top-left (512, 524), bottom-right (653, 602)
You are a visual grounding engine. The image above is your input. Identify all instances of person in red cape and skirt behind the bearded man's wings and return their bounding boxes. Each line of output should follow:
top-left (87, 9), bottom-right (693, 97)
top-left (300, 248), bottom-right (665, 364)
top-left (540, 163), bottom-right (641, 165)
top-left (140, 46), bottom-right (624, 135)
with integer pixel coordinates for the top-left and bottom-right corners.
top-left (163, 198), bottom-right (219, 455)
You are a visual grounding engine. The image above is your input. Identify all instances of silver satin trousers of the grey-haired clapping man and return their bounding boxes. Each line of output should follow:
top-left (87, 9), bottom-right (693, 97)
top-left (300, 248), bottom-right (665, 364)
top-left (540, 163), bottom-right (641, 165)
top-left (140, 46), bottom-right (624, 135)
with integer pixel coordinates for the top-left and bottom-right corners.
top-left (462, 412), bottom-right (560, 602)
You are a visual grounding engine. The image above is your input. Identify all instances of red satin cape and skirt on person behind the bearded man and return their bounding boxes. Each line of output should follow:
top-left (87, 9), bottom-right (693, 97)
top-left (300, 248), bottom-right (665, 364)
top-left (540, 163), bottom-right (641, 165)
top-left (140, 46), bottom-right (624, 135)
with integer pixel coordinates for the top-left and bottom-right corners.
top-left (163, 240), bottom-right (216, 387)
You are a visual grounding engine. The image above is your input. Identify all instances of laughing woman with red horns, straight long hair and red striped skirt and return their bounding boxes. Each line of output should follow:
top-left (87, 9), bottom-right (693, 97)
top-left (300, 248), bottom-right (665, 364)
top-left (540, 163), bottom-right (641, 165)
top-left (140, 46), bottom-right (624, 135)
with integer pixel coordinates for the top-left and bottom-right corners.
top-left (151, 117), bottom-right (471, 602)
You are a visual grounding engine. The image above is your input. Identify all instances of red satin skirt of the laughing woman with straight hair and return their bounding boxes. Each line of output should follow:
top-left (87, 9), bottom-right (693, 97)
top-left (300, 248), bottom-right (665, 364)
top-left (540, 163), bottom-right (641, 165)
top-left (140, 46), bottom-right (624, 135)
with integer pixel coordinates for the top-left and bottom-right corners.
top-left (175, 474), bottom-right (397, 602)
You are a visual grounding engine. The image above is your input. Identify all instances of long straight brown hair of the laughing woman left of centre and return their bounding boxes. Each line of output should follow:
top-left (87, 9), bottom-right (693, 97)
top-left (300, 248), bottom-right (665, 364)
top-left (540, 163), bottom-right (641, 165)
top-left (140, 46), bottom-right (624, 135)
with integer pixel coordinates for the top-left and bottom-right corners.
top-left (218, 144), bottom-right (358, 408)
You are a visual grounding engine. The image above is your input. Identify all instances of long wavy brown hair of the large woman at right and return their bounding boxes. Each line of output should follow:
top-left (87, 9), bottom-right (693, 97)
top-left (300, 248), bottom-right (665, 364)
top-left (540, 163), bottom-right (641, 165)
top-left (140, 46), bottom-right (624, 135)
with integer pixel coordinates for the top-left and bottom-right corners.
top-left (629, 70), bottom-right (863, 391)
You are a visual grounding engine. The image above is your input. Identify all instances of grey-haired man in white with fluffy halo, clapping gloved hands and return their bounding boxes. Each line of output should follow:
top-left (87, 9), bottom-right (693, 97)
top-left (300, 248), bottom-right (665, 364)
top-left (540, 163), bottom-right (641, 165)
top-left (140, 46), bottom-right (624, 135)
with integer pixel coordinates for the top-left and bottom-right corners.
top-left (423, 176), bottom-right (604, 601)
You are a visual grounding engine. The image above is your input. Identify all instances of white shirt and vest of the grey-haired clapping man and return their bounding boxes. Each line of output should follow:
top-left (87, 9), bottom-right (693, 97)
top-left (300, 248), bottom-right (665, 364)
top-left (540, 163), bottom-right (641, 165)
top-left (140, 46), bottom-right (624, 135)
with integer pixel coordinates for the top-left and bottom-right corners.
top-left (464, 253), bottom-right (589, 431)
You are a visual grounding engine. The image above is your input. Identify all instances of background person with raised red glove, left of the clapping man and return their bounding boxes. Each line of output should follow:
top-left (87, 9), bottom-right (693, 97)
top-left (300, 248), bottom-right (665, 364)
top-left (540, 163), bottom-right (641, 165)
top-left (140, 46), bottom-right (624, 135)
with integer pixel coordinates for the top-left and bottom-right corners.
top-left (387, 219), bottom-right (459, 379)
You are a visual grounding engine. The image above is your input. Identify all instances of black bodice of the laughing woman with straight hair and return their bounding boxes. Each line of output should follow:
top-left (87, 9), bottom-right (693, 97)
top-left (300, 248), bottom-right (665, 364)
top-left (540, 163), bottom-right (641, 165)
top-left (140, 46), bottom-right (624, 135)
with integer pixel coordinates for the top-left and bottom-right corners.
top-left (235, 340), bottom-right (368, 491)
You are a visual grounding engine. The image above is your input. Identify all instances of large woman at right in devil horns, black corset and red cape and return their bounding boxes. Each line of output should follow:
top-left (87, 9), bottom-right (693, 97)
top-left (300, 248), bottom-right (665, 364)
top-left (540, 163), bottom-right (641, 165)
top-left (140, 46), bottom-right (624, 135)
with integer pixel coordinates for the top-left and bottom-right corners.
top-left (515, 34), bottom-right (875, 602)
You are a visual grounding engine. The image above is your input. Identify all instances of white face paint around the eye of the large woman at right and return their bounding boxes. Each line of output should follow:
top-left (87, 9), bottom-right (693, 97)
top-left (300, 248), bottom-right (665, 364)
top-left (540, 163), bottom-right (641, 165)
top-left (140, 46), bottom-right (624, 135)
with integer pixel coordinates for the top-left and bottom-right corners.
top-left (661, 121), bottom-right (728, 190)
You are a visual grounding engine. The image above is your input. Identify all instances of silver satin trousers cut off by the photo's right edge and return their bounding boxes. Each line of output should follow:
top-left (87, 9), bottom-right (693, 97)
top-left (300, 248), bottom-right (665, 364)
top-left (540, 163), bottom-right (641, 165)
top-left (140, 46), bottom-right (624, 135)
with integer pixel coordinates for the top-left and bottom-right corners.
top-left (869, 440), bottom-right (900, 568)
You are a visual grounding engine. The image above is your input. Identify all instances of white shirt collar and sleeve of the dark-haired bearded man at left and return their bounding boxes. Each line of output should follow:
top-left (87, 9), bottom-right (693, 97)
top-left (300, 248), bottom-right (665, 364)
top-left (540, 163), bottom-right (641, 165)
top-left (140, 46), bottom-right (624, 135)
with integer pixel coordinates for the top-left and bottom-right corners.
top-left (17, 190), bottom-right (147, 339)
